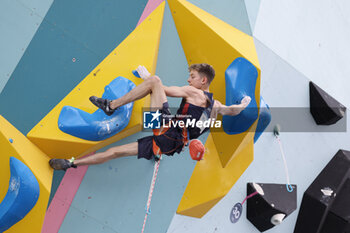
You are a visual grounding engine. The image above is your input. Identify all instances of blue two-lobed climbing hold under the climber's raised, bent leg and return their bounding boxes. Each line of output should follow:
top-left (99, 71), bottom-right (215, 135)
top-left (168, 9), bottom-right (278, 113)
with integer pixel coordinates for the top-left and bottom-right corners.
top-left (58, 77), bottom-right (136, 141)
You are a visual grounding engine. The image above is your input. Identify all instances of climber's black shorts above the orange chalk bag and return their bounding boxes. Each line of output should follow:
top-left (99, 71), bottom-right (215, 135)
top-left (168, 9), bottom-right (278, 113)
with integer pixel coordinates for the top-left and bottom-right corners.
top-left (137, 102), bottom-right (184, 160)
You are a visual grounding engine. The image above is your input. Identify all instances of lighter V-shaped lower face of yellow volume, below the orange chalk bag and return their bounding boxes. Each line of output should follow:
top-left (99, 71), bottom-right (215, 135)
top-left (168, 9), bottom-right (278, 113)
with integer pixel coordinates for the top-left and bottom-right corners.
top-left (177, 133), bottom-right (254, 218)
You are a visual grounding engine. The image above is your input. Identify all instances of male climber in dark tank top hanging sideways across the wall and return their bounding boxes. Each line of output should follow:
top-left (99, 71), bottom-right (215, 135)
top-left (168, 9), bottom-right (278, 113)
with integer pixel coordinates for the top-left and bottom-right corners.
top-left (50, 63), bottom-right (251, 170)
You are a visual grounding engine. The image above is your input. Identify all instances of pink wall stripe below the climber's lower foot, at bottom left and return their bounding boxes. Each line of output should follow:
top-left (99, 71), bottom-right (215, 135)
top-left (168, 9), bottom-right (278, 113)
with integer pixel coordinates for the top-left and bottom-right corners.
top-left (41, 156), bottom-right (88, 233)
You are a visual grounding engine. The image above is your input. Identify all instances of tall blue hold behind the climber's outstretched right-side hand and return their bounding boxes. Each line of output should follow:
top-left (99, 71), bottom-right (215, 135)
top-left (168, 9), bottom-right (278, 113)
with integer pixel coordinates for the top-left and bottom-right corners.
top-left (223, 57), bottom-right (258, 134)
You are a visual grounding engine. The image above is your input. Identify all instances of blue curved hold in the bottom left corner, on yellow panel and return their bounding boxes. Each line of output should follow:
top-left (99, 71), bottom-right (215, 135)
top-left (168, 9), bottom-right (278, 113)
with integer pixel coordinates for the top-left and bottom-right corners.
top-left (0, 157), bottom-right (40, 232)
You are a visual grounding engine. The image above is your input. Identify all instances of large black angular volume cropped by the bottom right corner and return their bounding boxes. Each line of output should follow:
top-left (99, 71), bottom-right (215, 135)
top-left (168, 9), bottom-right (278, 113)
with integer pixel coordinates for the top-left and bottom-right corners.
top-left (294, 150), bottom-right (350, 233)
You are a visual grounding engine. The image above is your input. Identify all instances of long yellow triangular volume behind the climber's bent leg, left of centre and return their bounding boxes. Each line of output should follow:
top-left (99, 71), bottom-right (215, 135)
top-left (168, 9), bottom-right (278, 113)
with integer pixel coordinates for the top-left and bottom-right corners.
top-left (27, 2), bottom-right (165, 158)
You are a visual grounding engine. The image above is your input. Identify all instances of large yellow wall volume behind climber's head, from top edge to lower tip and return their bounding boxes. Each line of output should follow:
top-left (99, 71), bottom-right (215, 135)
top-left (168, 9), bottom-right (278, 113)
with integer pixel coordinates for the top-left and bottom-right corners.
top-left (168, 0), bottom-right (261, 217)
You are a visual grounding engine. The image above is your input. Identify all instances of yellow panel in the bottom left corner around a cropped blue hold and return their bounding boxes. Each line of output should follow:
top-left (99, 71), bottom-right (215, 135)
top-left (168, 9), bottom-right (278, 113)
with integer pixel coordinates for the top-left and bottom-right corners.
top-left (0, 115), bottom-right (53, 233)
